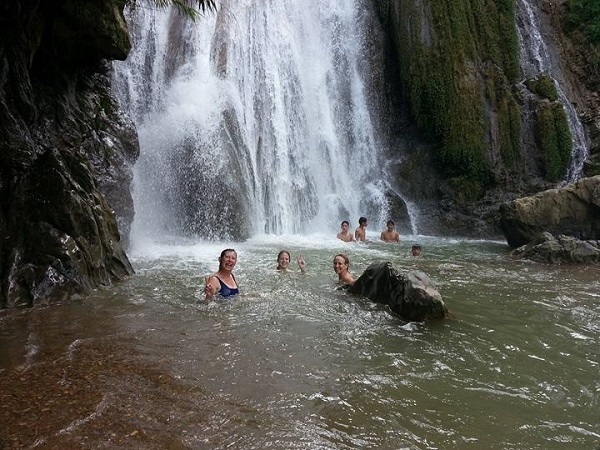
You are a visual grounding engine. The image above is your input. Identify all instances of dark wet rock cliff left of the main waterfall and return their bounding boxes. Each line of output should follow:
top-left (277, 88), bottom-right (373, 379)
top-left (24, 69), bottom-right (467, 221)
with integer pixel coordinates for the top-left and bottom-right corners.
top-left (0, 0), bottom-right (139, 307)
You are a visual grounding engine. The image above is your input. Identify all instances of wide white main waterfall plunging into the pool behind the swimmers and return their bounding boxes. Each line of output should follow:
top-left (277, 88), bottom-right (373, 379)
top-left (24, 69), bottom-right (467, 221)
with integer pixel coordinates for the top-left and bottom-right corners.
top-left (113, 0), bottom-right (398, 243)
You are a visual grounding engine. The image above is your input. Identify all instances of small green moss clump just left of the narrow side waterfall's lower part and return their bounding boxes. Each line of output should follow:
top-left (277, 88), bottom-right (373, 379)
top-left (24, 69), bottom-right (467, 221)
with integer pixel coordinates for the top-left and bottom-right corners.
top-left (536, 102), bottom-right (573, 182)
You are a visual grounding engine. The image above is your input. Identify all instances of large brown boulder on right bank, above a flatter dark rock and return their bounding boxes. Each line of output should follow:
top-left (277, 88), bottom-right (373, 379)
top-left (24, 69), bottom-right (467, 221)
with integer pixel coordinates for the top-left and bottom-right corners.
top-left (500, 176), bottom-right (600, 248)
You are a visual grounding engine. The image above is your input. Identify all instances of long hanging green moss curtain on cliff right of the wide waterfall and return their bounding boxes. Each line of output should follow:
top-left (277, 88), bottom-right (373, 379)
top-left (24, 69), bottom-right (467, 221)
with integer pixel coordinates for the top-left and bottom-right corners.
top-left (398, 0), bottom-right (520, 192)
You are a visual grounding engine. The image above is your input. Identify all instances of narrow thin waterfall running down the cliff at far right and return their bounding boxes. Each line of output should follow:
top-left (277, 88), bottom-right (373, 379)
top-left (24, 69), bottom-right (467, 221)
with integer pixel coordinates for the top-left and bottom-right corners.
top-left (517, 0), bottom-right (589, 183)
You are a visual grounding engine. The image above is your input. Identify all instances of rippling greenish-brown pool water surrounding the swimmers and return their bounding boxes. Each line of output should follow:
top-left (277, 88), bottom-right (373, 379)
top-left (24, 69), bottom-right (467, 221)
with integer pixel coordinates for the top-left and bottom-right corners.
top-left (0, 236), bottom-right (600, 449)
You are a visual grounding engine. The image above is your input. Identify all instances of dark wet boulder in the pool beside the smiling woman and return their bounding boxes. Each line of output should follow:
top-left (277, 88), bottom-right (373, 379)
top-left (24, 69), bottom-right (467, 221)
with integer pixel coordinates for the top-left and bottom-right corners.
top-left (348, 262), bottom-right (448, 322)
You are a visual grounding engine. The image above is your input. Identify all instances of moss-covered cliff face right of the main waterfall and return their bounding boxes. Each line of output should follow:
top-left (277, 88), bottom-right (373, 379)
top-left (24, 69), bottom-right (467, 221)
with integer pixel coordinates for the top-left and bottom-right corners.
top-left (376, 0), bottom-right (600, 237)
